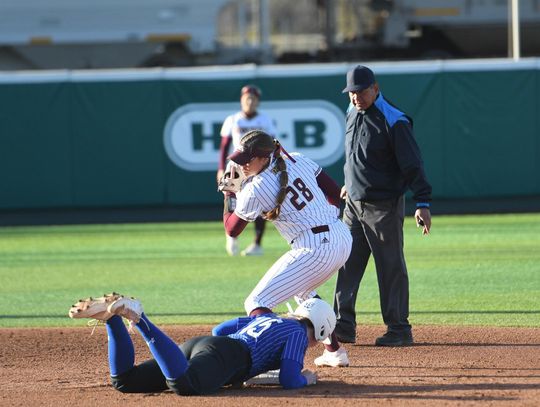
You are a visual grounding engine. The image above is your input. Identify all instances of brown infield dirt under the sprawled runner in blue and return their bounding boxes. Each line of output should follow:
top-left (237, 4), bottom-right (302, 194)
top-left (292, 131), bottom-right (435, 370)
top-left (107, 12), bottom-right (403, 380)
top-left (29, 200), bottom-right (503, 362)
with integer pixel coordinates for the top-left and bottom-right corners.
top-left (0, 326), bottom-right (540, 407)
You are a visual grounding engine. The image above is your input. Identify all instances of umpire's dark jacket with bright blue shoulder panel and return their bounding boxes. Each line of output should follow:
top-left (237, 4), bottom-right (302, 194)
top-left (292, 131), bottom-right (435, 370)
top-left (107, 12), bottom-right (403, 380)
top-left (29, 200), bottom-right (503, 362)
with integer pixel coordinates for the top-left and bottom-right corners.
top-left (344, 93), bottom-right (431, 202)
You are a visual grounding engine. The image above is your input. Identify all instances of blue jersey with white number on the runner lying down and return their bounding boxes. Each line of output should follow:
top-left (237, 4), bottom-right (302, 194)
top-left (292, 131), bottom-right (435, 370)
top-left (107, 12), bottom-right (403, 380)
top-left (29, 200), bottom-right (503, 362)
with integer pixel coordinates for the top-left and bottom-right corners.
top-left (228, 314), bottom-right (308, 377)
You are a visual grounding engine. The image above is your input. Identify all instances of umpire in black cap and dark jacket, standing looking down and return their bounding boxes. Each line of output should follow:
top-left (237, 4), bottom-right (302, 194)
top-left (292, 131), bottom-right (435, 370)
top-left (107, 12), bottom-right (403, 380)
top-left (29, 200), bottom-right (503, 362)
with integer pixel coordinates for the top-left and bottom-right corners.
top-left (334, 65), bottom-right (431, 346)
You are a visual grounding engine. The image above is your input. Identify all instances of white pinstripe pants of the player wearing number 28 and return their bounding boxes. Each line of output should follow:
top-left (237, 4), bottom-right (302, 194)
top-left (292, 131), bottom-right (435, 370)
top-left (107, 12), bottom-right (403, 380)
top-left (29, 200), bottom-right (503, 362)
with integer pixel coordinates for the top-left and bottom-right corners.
top-left (244, 220), bottom-right (352, 315)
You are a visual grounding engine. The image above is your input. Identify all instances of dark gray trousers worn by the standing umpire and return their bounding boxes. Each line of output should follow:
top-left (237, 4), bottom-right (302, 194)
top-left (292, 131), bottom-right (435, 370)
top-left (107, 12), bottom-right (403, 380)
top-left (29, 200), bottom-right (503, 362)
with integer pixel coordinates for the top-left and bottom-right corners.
top-left (334, 196), bottom-right (411, 338)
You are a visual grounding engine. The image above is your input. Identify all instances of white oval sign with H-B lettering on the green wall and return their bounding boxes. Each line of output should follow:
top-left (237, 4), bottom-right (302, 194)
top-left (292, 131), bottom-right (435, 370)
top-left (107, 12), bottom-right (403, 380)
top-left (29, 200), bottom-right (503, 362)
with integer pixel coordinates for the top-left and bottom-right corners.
top-left (163, 100), bottom-right (345, 171)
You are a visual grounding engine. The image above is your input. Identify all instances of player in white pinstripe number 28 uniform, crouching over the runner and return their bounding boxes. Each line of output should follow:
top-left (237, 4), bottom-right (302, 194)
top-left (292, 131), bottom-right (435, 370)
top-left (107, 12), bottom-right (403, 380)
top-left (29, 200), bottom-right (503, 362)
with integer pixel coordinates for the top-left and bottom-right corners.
top-left (224, 130), bottom-right (352, 366)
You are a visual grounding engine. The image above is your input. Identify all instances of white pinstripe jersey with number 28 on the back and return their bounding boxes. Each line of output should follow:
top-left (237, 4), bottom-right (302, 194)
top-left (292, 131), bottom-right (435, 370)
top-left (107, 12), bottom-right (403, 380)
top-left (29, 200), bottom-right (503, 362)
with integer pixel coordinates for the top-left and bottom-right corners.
top-left (234, 153), bottom-right (339, 243)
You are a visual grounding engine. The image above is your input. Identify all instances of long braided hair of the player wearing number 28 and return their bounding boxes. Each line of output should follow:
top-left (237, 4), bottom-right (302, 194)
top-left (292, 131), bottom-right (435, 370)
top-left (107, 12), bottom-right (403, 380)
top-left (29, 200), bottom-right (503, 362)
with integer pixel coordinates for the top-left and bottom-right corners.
top-left (240, 130), bottom-right (289, 220)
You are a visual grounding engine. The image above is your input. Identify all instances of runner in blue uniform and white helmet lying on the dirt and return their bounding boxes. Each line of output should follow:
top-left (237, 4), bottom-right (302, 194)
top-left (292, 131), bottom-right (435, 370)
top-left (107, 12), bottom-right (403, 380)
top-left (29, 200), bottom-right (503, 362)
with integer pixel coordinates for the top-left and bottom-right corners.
top-left (69, 293), bottom-right (336, 396)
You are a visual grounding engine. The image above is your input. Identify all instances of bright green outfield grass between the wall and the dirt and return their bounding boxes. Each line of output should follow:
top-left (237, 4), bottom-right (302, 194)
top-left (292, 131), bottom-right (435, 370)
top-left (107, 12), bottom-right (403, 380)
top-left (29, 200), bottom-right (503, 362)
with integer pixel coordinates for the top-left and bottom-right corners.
top-left (0, 214), bottom-right (540, 327)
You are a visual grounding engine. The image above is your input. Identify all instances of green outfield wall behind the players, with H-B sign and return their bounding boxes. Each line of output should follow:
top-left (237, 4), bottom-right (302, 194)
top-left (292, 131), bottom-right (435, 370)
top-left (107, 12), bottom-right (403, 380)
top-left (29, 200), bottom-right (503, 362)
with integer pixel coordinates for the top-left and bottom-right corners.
top-left (0, 59), bottom-right (540, 214)
